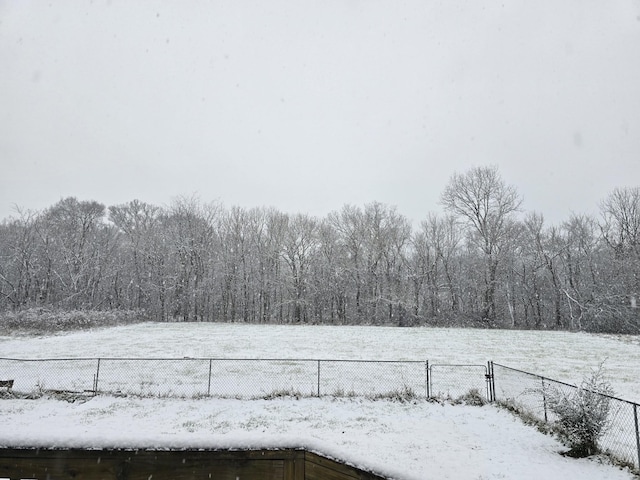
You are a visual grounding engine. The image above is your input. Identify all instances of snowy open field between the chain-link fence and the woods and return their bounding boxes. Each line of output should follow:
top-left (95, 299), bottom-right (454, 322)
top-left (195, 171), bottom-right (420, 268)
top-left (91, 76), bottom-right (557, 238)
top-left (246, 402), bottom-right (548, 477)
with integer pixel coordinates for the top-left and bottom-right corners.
top-left (0, 323), bottom-right (640, 401)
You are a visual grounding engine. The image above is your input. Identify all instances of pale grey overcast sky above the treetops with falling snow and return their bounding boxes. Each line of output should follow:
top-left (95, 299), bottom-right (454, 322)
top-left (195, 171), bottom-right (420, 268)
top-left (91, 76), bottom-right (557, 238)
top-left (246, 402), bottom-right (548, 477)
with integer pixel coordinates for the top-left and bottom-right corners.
top-left (0, 0), bottom-right (640, 223)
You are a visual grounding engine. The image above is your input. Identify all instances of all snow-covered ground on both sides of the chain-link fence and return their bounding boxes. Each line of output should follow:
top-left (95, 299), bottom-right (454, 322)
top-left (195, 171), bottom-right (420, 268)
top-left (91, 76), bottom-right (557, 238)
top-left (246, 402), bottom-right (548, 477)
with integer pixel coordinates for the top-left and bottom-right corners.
top-left (0, 324), bottom-right (640, 480)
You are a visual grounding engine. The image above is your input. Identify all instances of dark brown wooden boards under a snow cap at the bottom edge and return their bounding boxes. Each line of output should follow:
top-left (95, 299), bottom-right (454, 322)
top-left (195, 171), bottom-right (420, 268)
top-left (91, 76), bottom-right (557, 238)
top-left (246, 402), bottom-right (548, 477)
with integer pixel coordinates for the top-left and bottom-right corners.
top-left (0, 448), bottom-right (385, 480)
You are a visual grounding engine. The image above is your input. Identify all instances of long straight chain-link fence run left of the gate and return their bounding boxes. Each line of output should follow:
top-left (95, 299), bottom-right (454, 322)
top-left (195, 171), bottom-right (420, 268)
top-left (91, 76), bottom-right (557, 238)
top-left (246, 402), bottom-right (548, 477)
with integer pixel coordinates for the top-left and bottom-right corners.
top-left (0, 358), bottom-right (436, 399)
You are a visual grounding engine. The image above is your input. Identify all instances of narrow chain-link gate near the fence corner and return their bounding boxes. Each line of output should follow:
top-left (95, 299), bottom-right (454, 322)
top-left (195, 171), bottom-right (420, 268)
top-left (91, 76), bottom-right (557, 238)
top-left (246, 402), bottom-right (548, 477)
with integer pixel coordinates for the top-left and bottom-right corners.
top-left (427, 364), bottom-right (493, 401)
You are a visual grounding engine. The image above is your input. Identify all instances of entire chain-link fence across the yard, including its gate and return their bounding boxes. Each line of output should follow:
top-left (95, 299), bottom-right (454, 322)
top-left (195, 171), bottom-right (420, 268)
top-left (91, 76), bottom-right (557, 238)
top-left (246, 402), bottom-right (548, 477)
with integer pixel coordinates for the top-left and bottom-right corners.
top-left (0, 358), bottom-right (640, 469)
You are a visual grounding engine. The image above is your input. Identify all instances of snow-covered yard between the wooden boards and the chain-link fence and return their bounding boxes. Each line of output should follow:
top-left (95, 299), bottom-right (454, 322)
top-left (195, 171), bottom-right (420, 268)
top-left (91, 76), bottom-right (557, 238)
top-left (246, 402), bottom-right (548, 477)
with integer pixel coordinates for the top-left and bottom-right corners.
top-left (0, 397), bottom-right (633, 480)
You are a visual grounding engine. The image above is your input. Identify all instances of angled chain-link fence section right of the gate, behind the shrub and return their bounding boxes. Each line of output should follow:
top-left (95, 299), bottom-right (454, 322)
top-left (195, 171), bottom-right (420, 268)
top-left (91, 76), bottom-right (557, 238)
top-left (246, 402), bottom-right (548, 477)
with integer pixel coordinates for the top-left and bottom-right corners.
top-left (490, 362), bottom-right (640, 470)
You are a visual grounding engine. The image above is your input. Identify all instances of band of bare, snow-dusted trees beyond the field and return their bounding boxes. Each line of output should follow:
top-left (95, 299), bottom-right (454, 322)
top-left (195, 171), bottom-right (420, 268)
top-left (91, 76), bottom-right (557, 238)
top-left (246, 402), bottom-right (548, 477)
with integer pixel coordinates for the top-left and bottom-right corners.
top-left (0, 167), bottom-right (640, 333)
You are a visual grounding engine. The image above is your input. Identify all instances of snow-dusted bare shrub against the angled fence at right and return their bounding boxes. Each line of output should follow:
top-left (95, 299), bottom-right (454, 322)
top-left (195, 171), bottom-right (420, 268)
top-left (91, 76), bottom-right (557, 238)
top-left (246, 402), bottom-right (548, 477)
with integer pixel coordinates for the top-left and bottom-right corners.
top-left (543, 365), bottom-right (613, 457)
